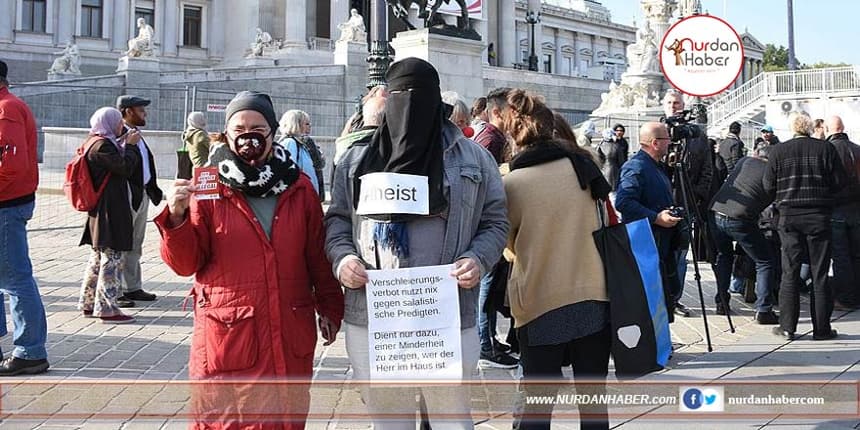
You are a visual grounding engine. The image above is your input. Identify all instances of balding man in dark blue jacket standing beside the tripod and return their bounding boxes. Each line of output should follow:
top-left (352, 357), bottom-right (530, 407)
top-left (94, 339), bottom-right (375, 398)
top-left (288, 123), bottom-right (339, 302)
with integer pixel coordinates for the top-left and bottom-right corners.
top-left (615, 122), bottom-right (682, 322)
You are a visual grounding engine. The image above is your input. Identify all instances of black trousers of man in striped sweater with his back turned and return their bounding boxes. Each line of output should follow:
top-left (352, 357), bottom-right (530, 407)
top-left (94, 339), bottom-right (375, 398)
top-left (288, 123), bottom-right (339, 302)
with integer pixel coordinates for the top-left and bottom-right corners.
top-left (779, 212), bottom-right (833, 335)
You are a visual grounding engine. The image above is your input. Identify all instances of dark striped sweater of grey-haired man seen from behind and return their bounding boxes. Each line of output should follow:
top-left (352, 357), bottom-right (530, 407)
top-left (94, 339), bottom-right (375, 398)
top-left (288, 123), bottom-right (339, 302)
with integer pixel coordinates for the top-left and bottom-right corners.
top-left (762, 136), bottom-right (848, 215)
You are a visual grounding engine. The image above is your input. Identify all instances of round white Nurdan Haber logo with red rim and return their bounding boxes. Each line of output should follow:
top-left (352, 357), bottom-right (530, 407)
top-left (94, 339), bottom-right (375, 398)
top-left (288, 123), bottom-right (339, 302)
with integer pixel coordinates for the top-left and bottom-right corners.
top-left (660, 15), bottom-right (744, 97)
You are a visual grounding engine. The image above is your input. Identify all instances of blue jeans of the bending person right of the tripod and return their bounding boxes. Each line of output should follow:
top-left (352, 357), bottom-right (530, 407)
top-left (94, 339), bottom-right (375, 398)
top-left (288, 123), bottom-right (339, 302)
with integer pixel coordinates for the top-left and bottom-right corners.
top-left (713, 214), bottom-right (776, 312)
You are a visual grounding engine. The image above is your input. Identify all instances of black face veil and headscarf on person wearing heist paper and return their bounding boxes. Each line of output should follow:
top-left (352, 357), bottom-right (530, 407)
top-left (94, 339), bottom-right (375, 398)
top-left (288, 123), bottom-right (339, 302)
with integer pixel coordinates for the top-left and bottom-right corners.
top-left (353, 58), bottom-right (448, 222)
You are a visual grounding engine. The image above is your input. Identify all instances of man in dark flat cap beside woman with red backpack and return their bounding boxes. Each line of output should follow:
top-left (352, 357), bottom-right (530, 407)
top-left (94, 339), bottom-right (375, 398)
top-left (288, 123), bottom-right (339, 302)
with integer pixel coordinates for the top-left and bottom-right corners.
top-left (116, 95), bottom-right (164, 308)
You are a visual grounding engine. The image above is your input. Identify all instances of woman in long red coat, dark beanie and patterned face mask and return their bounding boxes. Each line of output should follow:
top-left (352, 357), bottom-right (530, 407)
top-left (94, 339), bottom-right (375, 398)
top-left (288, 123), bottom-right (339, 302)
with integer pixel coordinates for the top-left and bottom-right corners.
top-left (155, 92), bottom-right (343, 428)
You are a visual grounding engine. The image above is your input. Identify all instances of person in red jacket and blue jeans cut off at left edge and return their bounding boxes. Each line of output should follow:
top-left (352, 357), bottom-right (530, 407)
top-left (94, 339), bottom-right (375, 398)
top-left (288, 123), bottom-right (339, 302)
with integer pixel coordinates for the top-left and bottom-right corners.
top-left (0, 61), bottom-right (49, 376)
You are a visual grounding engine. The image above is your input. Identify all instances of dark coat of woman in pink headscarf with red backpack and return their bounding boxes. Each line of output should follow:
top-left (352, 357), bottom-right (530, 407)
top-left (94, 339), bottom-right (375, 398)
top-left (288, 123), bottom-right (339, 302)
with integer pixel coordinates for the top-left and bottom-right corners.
top-left (80, 139), bottom-right (140, 251)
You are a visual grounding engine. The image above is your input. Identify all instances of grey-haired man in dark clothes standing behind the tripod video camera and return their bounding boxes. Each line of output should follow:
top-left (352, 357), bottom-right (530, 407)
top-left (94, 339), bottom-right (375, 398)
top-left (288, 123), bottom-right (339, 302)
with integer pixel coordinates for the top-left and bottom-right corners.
top-left (661, 90), bottom-right (714, 317)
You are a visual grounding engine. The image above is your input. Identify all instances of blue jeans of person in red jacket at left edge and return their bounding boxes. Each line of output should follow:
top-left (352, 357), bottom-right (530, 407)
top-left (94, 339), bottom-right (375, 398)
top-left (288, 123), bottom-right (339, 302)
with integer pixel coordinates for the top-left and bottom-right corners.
top-left (0, 202), bottom-right (48, 360)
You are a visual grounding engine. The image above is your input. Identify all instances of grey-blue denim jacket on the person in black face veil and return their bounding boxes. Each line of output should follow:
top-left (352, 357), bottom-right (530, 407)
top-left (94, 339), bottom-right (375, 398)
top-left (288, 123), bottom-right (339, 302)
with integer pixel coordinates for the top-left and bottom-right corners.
top-left (325, 122), bottom-right (510, 329)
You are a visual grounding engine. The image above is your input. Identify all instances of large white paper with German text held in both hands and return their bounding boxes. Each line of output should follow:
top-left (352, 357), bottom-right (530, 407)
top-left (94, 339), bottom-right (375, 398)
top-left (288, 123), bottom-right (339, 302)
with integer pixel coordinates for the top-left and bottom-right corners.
top-left (367, 265), bottom-right (463, 380)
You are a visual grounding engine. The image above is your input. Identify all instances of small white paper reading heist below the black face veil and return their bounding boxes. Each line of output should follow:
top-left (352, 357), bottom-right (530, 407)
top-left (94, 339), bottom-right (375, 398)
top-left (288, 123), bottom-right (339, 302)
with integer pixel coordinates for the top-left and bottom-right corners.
top-left (355, 172), bottom-right (430, 215)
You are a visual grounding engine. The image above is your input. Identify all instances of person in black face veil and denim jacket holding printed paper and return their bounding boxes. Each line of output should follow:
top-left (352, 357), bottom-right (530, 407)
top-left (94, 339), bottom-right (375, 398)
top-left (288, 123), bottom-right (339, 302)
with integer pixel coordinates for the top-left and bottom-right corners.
top-left (326, 58), bottom-right (509, 429)
